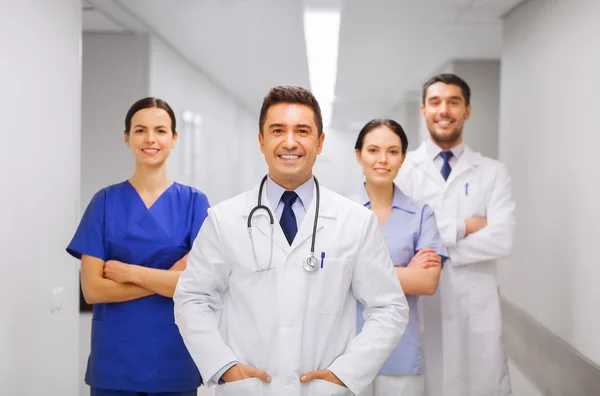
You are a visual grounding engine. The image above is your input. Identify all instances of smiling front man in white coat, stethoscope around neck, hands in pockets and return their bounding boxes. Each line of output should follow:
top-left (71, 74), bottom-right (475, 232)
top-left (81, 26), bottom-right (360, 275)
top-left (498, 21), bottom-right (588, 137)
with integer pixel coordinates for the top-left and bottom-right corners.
top-left (174, 87), bottom-right (408, 396)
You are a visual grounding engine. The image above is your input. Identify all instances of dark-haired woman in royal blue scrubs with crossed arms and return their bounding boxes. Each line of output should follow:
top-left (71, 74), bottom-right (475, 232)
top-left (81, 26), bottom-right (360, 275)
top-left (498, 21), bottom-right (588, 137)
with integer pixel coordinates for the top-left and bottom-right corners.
top-left (67, 98), bottom-right (209, 396)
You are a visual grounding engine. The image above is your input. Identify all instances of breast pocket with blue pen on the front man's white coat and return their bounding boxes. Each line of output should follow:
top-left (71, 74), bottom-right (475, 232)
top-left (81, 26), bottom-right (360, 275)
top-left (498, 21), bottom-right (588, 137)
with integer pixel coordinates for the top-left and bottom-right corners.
top-left (308, 258), bottom-right (350, 314)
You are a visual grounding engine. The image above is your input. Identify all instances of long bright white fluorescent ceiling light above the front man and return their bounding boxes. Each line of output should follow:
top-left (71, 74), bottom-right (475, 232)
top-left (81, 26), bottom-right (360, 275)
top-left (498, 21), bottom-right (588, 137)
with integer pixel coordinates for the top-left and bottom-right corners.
top-left (304, 8), bottom-right (340, 127)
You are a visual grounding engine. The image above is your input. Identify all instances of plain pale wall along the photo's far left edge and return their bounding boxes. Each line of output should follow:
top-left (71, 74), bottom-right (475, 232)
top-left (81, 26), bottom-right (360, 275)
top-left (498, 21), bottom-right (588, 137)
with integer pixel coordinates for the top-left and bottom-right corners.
top-left (0, 0), bottom-right (81, 396)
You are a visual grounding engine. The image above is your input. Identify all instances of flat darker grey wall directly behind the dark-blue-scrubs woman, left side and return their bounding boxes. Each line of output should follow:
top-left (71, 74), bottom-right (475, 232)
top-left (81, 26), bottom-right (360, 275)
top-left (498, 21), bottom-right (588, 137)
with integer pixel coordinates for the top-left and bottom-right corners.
top-left (77, 33), bottom-right (150, 396)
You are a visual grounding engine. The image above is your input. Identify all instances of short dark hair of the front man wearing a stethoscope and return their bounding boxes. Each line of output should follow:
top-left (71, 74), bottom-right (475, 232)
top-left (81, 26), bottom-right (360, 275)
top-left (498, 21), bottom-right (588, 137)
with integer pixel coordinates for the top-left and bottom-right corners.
top-left (258, 85), bottom-right (323, 136)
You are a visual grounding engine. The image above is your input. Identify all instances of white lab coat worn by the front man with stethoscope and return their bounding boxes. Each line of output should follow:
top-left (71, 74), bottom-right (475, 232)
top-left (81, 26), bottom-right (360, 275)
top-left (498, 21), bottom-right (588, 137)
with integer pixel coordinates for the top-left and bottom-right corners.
top-left (174, 183), bottom-right (408, 396)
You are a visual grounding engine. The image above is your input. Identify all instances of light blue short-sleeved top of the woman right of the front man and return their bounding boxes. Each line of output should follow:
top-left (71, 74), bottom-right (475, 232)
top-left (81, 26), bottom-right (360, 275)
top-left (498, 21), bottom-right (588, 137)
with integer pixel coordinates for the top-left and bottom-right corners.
top-left (357, 185), bottom-right (448, 375)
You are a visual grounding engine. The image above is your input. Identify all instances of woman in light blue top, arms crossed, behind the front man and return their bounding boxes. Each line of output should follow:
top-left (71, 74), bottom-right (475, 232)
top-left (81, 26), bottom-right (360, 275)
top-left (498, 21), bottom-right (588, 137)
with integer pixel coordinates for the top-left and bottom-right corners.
top-left (355, 120), bottom-right (448, 396)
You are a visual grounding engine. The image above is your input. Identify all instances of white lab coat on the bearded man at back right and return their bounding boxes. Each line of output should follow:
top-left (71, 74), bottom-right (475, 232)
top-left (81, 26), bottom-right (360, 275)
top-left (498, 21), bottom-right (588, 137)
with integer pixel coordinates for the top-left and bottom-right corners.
top-left (396, 144), bottom-right (515, 396)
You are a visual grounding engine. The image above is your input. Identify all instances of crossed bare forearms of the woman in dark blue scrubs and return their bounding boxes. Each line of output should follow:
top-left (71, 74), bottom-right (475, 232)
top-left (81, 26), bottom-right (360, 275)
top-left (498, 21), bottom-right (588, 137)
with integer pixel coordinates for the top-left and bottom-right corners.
top-left (81, 255), bottom-right (187, 304)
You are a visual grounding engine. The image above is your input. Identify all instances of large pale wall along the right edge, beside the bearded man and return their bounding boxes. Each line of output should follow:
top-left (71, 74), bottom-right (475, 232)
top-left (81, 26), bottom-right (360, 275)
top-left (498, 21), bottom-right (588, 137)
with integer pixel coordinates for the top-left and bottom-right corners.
top-left (499, 0), bottom-right (600, 366)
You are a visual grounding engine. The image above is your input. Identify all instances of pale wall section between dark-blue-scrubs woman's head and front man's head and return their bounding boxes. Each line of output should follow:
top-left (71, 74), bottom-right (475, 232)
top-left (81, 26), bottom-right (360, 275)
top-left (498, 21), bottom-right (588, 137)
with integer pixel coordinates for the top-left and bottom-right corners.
top-left (150, 38), bottom-right (270, 204)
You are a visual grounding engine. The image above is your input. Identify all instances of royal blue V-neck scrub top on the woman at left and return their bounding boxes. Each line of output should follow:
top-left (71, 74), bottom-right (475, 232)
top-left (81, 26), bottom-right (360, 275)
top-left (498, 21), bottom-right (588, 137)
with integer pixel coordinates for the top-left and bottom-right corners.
top-left (67, 181), bottom-right (209, 392)
